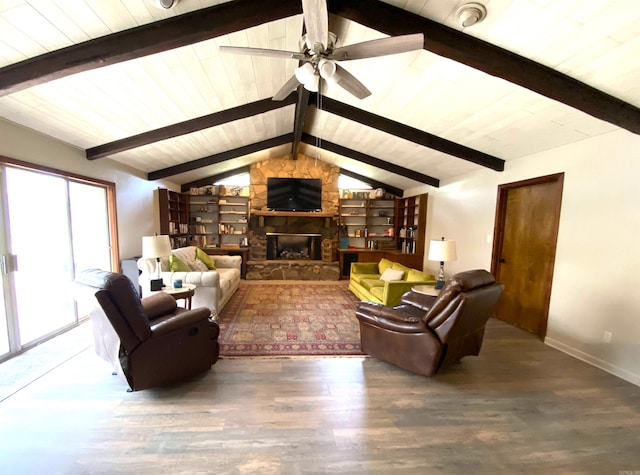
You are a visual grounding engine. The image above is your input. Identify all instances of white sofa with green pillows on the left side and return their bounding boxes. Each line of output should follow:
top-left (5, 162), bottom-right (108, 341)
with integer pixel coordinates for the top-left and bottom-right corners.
top-left (138, 246), bottom-right (242, 317)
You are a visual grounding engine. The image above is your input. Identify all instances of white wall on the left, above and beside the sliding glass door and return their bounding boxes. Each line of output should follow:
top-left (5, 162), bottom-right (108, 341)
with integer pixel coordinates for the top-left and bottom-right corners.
top-left (0, 120), bottom-right (179, 259)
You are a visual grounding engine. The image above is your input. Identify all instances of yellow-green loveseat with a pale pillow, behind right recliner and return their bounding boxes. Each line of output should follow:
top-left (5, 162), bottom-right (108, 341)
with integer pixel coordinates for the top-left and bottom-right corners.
top-left (349, 259), bottom-right (436, 307)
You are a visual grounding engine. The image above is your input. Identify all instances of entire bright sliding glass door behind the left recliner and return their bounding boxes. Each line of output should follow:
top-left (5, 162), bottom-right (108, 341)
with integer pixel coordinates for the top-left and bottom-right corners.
top-left (0, 166), bottom-right (112, 358)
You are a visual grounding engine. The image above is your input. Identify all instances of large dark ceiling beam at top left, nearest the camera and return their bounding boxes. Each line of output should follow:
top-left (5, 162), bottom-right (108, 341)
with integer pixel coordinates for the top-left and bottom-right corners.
top-left (0, 0), bottom-right (302, 96)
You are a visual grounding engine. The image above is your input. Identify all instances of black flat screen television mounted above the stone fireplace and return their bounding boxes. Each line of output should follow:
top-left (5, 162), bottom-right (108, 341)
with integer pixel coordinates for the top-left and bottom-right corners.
top-left (267, 178), bottom-right (322, 211)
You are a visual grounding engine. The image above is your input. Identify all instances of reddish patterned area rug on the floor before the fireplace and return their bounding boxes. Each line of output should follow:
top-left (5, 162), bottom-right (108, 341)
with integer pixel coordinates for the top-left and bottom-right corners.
top-left (218, 281), bottom-right (362, 356)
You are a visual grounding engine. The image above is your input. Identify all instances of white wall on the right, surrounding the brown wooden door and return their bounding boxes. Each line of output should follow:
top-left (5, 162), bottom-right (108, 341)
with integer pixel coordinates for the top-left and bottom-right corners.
top-left (411, 131), bottom-right (640, 385)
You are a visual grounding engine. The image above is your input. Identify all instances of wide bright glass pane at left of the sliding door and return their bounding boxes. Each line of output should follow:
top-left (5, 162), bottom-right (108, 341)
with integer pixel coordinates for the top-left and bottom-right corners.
top-left (6, 167), bottom-right (76, 345)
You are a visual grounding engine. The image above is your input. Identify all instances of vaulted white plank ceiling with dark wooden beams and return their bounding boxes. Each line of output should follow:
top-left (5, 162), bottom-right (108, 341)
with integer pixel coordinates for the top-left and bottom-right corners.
top-left (0, 0), bottom-right (640, 194)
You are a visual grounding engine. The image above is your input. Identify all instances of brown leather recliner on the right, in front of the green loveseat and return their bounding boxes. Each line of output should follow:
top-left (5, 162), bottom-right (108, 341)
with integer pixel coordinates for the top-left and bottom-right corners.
top-left (356, 270), bottom-right (504, 376)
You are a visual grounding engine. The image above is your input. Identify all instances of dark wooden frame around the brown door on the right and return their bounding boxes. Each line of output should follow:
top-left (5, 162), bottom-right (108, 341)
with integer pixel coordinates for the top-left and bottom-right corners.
top-left (491, 172), bottom-right (564, 341)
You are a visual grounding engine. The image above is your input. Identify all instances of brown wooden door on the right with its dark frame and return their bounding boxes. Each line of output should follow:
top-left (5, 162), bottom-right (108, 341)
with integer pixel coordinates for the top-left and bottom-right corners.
top-left (491, 173), bottom-right (564, 340)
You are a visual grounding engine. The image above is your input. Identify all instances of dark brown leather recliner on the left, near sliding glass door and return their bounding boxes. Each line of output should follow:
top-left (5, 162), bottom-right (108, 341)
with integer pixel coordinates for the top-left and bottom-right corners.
top-left (74, 269), bottom-right (220, 391)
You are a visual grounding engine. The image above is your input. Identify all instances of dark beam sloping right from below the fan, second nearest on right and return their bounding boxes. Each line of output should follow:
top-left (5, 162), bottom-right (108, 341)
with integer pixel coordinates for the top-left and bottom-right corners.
top-left (322, 97), bottom-right (505, 172)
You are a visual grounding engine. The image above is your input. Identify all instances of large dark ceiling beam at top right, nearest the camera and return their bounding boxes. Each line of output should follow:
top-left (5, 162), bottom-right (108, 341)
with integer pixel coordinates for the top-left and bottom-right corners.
top-left (328, 0), bottom-right (640, 134)
